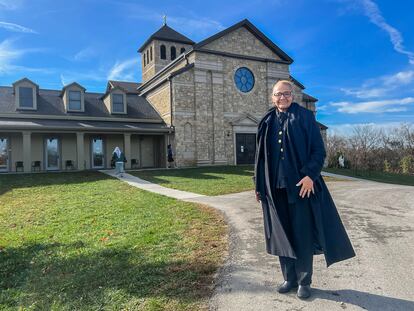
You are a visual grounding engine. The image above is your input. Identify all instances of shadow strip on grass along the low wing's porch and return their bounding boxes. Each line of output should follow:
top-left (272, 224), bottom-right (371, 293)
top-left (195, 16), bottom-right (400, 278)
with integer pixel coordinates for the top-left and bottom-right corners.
top-left (0, 171), bottom-right (112, 195)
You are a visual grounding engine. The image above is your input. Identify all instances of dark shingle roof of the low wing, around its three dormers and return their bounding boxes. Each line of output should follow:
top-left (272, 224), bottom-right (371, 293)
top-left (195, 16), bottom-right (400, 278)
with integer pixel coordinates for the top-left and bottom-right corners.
top-left (0, 87), bottom-right (162, 121)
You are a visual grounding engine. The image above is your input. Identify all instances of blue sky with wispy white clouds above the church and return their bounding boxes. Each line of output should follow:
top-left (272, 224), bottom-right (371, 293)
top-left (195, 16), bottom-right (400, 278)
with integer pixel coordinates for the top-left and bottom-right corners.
top-left (0, 0), bottom-right (414, 132)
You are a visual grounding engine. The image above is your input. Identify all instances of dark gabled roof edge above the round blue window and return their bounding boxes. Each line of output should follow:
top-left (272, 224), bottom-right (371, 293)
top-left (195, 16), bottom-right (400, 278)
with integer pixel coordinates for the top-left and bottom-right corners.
top-left (194, 19), bottom-right (293, 64)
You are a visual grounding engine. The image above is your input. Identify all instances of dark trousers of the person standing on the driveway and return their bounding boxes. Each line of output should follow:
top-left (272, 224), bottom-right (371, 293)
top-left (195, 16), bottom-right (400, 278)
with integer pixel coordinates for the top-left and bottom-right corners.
top-left (274, 188), bottom-right (314, 285)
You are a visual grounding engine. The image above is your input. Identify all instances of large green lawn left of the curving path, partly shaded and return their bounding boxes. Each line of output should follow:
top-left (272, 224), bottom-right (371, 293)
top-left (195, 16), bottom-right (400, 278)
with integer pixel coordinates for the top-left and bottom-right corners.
top-left (0, 172), bottom-right (227, 311)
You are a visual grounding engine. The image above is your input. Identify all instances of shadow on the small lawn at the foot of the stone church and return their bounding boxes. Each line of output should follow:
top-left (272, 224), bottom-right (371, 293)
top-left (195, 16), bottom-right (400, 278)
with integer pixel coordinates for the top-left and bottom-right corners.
top-left (134, 165), bottom-right (254, 184)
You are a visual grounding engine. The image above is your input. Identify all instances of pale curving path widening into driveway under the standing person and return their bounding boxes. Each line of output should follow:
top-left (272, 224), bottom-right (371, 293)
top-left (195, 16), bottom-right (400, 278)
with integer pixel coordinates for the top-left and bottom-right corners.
top-left (101, 174), bottom-right (414, 311)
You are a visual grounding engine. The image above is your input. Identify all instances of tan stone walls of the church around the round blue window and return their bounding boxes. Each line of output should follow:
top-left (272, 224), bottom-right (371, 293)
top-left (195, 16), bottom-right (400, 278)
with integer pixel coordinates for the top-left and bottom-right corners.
top-left (141, 20), bottom-right (324, 166)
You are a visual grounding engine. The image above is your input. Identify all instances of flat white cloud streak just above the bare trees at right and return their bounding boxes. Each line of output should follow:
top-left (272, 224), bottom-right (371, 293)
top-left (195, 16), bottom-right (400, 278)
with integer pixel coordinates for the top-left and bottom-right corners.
top-left (330, 97), bottom-right (414, 114)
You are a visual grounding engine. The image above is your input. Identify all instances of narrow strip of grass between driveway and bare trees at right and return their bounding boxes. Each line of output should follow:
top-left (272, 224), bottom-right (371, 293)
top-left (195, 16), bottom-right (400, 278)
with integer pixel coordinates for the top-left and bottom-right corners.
top-left (323, 168), bottom-right (414, 186)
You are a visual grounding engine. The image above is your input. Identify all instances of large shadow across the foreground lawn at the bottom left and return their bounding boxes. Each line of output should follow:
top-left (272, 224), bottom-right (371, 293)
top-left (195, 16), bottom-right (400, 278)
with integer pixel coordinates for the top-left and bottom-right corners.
top-left (0, 241), bottom-right (217, 310)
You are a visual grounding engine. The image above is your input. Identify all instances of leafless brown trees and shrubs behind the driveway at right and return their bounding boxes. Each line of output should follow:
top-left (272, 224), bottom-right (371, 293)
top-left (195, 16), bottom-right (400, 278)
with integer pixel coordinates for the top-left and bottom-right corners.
top-left (326, 123), bottom-right (414, 175)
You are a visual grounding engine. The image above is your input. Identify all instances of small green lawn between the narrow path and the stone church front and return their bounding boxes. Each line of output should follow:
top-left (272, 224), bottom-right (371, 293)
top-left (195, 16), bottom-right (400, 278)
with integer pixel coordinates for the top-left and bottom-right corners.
top-left (132, 165), bottom-right (254, 195)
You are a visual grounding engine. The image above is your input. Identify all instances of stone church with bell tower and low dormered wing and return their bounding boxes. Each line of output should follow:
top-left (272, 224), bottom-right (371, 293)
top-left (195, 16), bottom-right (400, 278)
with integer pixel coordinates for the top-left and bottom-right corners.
top-left (0, 19), bottom-right (327, 172)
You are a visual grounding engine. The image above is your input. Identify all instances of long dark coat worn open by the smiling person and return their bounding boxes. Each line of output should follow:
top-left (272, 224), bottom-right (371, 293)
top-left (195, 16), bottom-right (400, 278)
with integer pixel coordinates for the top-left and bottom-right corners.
top-left (254, 103), bottom-right (355, 266)
